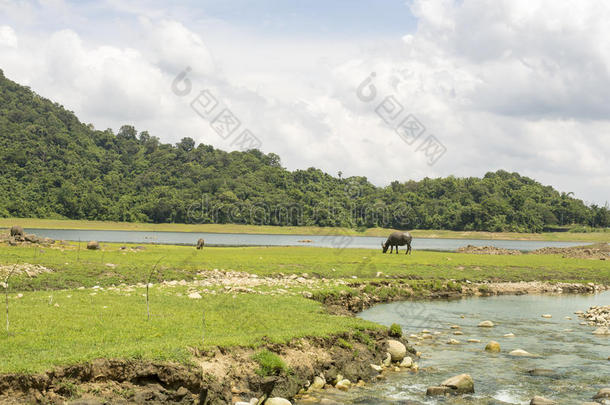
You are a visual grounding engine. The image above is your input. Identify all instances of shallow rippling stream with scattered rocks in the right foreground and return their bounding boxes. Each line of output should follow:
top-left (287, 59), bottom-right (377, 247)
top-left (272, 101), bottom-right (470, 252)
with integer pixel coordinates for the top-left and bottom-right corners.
top-left (300, 291), bottom-right (610, 405)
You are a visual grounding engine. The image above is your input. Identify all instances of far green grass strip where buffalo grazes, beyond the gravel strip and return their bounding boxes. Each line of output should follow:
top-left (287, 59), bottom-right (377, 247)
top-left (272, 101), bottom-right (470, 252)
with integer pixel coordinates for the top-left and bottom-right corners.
top-left (0, 243), bottom-right (610, 291)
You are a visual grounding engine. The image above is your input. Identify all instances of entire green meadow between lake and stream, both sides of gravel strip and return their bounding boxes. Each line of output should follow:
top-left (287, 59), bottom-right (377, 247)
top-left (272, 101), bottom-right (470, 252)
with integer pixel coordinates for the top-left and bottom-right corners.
top-left (0, 243), bottom-right (610, 373)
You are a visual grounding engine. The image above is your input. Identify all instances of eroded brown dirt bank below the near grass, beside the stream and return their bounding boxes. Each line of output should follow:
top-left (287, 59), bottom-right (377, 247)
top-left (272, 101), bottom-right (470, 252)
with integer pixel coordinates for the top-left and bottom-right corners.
top-left (0, 330), bottom-right (415, 405)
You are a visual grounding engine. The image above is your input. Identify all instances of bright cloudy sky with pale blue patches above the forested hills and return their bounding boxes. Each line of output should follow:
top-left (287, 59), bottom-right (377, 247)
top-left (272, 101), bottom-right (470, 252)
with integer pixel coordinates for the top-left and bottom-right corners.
top-left (0, 0), bottom-right (610, 204)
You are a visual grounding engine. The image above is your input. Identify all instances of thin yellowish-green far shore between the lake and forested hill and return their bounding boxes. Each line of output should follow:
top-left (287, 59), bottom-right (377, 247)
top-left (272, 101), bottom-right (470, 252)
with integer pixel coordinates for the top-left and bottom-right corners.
top-left (0, 218), bottom-right (610, 242)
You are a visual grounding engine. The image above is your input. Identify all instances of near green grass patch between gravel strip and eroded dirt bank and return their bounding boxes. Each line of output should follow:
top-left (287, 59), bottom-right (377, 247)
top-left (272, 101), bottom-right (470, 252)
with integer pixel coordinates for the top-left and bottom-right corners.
top-left (0, 288), bottom-right (377, 373)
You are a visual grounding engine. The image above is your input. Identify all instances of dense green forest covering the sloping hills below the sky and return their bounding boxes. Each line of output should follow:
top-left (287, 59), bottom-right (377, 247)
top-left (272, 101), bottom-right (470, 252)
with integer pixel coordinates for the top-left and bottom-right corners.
top-left (0, 70), bottom-right (610, 232)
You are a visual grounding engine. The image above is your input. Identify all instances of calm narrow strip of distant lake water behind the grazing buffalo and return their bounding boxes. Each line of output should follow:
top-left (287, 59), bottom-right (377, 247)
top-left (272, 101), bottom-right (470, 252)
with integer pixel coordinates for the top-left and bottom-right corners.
top-left (26, 228), bottom-right (584, 251)
